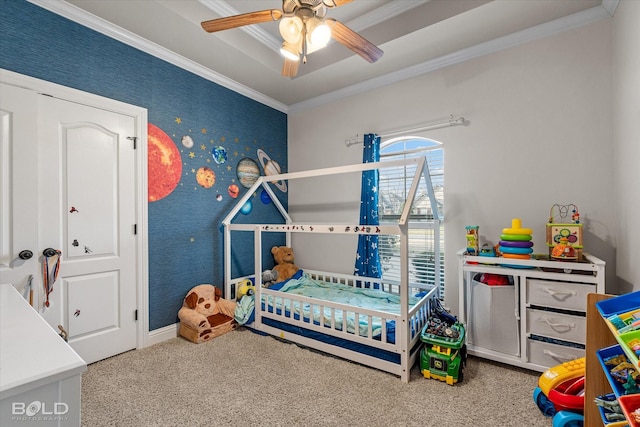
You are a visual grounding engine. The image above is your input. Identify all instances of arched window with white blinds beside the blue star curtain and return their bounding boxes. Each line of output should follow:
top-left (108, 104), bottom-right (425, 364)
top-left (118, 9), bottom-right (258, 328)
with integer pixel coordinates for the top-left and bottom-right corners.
top-left (378, 136), bottom-right (444, 299)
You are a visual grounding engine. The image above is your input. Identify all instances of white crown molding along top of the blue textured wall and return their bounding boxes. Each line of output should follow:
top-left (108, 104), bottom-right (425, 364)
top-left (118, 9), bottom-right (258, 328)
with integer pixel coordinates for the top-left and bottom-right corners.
top-left (27, 0), bottom-right (287, 113)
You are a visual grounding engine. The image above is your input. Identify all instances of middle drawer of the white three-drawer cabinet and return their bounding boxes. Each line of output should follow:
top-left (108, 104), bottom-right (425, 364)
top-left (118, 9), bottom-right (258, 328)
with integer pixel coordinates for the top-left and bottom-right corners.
top-left (527, 308), bottom-right (587, 344)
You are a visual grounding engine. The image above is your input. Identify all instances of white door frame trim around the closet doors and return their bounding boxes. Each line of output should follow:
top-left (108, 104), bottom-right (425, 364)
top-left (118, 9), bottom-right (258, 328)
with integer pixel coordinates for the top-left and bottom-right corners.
top-left (0, 68), bottom-right (152, 348)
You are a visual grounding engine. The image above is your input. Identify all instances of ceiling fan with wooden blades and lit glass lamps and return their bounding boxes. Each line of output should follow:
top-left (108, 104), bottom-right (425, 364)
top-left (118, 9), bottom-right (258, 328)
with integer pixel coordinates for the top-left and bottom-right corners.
top-left (201, 0), bottom-right (383, 77)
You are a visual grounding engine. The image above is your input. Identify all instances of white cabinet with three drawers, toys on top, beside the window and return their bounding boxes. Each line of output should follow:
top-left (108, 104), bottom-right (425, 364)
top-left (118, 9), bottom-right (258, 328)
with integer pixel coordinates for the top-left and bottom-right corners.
top-left (458, 250), bottom-right (605, 372)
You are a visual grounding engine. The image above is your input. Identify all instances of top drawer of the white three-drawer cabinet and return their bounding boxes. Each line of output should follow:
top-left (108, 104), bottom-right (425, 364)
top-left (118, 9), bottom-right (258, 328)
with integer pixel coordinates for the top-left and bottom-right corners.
top-left (527, 279), bottom-right (596, 311)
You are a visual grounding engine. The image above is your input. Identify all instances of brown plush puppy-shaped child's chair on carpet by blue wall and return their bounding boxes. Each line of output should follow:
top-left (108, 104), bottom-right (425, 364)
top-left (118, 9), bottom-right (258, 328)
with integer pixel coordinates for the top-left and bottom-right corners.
top-left (178, 284), bottom-right (237, 343)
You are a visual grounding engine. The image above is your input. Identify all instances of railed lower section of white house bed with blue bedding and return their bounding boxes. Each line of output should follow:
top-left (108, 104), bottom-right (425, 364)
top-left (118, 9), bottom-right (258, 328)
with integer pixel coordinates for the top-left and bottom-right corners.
top-left (229, 270), bottom-right (437, 382)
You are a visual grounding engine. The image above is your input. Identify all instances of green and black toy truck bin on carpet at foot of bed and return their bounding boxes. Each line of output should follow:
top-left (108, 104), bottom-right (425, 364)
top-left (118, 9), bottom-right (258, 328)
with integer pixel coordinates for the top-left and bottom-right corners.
top-left (420, 322), bottom-right (467, 385)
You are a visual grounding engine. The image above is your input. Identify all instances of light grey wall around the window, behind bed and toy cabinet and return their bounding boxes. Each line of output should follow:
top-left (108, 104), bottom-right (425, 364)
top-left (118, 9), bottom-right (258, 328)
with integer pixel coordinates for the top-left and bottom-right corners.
top-left (289, 20), bottom-right (616, 312)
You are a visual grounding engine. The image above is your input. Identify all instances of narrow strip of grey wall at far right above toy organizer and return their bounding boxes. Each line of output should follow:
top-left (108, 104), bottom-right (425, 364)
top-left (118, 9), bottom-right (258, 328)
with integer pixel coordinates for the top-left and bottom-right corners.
top-left (613, 0), bottom-right (640, 293)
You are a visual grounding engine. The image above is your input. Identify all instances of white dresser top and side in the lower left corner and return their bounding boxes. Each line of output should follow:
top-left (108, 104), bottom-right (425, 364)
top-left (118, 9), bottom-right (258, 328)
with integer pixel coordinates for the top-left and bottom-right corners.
top-left (0, 284), bottom-right (87, 427)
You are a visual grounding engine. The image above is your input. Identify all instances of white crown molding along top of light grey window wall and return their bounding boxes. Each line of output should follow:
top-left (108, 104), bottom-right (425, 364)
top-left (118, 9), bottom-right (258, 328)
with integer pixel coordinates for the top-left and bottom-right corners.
top-left (287, 0), bottom-right (619, 113)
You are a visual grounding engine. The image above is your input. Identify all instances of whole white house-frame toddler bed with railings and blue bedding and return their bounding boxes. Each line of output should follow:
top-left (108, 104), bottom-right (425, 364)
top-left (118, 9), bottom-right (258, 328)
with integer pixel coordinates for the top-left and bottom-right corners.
top-left (223, 157), bottom-right (440, 382)
